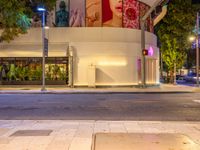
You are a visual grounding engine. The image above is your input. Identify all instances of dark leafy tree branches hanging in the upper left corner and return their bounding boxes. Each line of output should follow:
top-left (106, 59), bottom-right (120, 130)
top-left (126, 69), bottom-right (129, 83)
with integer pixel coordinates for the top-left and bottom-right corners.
top-left (0, 0), bottom-right (56, 42)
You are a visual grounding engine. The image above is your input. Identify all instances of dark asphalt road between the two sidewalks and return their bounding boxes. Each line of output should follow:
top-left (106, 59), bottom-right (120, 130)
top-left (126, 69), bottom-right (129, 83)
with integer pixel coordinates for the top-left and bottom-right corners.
top-left (0, 93), bottom-right (200, 121)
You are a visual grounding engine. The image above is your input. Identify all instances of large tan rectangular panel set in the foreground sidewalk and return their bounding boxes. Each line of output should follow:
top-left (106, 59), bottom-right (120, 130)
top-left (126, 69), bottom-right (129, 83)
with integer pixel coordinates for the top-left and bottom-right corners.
top-left (92, 133), bottom-right (200, 150)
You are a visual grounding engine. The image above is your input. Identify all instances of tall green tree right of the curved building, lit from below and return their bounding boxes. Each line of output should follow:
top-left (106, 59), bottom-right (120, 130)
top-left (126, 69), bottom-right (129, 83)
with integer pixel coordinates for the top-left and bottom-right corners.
top-left (156, 0), bottom-right (200, 82)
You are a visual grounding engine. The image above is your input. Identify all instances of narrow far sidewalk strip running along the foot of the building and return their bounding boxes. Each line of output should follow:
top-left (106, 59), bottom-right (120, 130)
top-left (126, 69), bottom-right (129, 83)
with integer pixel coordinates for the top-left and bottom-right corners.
top-left (0, 84), bottom-right (200, 94)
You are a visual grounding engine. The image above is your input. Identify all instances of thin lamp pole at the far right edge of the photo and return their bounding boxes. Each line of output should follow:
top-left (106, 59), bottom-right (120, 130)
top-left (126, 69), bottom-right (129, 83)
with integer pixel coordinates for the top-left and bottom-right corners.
top-left (196, 12), bottom-right (199, 87)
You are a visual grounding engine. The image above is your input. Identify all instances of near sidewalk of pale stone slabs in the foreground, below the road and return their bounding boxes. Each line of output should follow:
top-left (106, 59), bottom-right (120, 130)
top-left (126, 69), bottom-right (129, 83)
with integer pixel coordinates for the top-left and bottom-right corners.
top-left (0, 120), bottom-right (200, 150)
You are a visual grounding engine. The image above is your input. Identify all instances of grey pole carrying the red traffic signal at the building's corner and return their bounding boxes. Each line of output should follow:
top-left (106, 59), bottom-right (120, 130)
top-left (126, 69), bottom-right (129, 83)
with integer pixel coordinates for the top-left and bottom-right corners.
top-left (141, 20), bottom-right (146, 88)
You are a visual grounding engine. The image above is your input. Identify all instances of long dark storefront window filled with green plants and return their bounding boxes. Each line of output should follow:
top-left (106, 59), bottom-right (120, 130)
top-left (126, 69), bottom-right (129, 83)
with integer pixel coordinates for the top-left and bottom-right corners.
top-left (0, 57), bottom-right (68, 84)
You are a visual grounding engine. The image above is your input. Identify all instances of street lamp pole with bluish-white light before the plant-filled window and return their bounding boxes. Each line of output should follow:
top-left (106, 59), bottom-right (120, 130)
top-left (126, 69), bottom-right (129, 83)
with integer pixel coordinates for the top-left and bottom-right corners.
top-left (41, 11), bottom-right (46, 91)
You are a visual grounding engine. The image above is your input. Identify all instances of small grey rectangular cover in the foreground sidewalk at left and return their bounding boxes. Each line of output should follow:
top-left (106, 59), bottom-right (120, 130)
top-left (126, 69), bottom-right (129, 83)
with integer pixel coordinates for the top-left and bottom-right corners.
top-left (10, 130), bottom-right (52, 136)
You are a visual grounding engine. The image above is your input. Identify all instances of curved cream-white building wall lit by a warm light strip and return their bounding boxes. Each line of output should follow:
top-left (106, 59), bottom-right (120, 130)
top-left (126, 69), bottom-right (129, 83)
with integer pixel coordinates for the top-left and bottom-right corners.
top-left (0, 27), bottom-right (159, 86)
